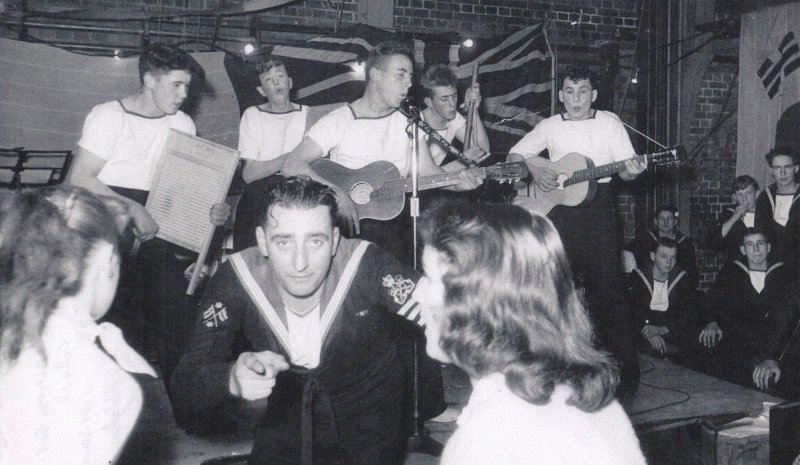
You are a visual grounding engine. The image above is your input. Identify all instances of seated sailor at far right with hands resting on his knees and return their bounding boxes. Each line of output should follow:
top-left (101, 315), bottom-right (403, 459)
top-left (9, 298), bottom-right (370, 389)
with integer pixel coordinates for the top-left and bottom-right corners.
top-left (699, 228), bottom-right (798, 389)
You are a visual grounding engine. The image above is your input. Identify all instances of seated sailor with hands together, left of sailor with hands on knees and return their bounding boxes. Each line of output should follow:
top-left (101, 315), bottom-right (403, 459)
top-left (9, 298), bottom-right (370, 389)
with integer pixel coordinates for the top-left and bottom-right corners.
top-left (629, 237), bottom-right (697, 363)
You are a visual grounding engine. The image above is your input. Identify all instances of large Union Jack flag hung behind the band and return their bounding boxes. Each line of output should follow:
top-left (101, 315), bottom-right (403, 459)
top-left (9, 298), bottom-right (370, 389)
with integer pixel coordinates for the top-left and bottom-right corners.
top-left (226, 24), bottom-right (552, 152)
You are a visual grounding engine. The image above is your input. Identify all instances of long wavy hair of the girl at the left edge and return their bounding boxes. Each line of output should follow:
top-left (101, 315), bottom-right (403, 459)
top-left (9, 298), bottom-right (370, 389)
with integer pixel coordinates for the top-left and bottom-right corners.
top-left (0, 186), bottom-right (126, 364)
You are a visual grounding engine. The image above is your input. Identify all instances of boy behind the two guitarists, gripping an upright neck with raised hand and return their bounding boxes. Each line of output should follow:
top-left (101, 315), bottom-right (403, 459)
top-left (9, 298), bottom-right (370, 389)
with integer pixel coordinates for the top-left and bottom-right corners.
top-left (420, 64), bottom-right (489, 171)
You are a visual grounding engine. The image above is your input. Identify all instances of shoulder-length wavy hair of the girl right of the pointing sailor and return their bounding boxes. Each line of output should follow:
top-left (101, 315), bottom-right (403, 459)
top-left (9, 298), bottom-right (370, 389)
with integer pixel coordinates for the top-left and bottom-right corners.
top-left (421, 201), bottom-right (619, 412)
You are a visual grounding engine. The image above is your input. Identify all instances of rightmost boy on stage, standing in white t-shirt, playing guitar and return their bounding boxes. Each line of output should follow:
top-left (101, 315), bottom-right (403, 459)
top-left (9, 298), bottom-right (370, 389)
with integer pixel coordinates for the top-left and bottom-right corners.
top-left (508, 69), bottom-right (647, 395)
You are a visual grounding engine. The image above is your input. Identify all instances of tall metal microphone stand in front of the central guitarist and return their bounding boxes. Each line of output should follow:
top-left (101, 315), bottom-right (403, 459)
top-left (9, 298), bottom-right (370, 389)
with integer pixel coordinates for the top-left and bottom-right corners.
top-left (403, 100), bottom-right (443, 457)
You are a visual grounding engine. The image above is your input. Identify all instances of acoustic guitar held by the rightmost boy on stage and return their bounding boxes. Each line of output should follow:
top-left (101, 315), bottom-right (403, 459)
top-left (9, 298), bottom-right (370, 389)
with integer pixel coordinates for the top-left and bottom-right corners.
top-left (513, 146), bottom-right (686, 215)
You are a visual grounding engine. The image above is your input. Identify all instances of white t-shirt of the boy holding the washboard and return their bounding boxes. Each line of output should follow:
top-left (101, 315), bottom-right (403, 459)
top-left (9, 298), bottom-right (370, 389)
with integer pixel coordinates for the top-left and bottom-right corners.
top-left (78, 100), bottom-right (196, 191)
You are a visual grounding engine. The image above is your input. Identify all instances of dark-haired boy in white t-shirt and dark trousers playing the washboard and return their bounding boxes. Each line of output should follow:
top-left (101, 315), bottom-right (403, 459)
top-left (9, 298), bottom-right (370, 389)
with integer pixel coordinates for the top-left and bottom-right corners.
top-left (66, 43), bottom-right (230, 396)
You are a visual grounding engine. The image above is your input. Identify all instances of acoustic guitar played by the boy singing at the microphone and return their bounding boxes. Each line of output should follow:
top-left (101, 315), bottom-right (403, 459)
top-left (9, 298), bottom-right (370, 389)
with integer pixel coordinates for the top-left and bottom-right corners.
top-left (311, 158), bottom-right (529, 221)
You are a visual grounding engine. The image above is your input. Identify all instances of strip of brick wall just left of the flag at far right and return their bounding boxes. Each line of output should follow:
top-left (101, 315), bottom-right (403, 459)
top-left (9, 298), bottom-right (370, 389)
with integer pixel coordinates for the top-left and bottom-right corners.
top-left (684, 62), bottom-right (738, 289)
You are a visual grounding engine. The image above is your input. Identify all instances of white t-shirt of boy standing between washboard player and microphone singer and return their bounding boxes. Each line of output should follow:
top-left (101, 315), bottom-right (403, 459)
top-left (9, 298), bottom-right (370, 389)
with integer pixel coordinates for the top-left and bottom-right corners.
top-left (239, 105), bottom-right (308, 161)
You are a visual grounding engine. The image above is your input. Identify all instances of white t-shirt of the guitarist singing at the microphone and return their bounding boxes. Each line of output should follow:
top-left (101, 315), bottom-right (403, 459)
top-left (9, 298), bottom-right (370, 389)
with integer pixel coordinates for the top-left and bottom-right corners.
top-left (308, 105), bottom-right (410, 176)
